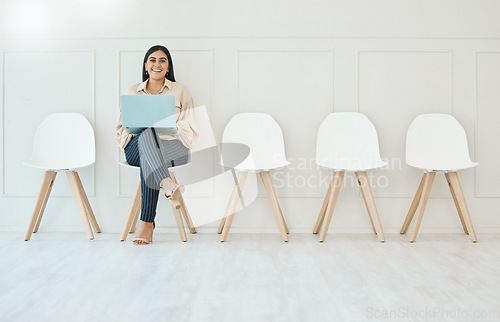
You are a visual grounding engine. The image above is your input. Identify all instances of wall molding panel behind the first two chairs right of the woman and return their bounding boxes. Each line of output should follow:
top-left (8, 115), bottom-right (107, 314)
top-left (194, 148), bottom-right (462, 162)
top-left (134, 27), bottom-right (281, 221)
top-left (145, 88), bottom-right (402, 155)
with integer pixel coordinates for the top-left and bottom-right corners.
top-left (236, 48), bottom-right (335, 198)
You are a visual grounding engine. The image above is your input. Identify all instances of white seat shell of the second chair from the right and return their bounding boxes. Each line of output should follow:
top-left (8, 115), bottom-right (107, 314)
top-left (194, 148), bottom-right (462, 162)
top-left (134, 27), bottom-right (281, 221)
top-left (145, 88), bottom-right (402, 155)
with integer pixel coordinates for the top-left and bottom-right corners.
top-left (316, 112), bottom-right (387, 171)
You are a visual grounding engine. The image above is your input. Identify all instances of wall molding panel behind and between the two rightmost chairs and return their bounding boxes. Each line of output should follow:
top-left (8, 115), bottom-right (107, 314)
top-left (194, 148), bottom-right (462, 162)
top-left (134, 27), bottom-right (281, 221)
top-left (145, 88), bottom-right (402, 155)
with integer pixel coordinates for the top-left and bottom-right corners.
top-left (357, 50), bottom-right (453, 198)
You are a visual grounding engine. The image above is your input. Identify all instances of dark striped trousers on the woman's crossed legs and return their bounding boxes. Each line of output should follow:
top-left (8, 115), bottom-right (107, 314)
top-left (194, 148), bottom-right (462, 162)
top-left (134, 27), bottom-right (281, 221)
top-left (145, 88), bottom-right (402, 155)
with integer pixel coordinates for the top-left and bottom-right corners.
top-left (125, 128), bottom-right (189, 222)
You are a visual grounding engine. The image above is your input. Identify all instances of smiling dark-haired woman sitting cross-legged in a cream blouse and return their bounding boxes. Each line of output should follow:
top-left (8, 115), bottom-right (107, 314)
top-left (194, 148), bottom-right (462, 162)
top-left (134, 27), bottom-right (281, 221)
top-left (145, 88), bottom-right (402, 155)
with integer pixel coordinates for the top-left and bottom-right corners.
top-left (116, 45), bottom-right (199, 245)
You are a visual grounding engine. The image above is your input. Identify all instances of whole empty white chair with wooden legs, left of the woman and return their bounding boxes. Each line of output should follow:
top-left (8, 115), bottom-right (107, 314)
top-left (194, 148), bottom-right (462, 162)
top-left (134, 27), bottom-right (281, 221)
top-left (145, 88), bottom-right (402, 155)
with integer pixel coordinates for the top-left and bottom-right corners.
top-left (24, 113), bottom-right (101, 241)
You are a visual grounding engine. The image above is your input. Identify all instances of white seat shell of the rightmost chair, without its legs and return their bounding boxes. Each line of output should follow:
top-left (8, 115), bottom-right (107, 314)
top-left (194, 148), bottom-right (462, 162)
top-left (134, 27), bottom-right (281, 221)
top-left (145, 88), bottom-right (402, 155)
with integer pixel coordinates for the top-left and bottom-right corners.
top-left (406, 114), bottom-right (477, 170)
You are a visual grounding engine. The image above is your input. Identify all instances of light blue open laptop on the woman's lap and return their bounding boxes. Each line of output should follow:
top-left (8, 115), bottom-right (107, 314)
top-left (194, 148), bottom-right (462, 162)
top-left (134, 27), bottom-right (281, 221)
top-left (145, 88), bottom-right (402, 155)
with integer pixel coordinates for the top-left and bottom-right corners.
top-left (120, 95), bottom-right (177, 134)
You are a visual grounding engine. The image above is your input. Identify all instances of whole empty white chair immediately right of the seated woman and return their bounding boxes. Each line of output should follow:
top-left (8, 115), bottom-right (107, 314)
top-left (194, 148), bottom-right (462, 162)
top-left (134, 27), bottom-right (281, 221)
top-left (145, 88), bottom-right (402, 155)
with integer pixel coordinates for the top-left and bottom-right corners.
top-left (218, 113), bottom-right (289, 242)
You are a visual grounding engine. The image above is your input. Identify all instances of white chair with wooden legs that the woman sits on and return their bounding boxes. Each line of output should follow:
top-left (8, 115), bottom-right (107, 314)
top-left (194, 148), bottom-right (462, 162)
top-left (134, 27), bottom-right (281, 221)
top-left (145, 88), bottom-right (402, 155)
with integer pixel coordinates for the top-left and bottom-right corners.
top-left (120, 105), bottom-right (215, 242)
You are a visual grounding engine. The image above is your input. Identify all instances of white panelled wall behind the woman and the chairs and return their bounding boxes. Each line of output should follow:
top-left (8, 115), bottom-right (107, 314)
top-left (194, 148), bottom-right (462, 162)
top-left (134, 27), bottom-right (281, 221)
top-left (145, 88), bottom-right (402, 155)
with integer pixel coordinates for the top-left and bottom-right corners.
top-left (0, 0), bottom-right (500, 233)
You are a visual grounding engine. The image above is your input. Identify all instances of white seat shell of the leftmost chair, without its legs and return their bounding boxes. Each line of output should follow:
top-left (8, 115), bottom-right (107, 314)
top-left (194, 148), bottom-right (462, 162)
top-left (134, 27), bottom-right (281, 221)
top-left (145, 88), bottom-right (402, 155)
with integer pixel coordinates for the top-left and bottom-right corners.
top-left (27, 113), bottom-right (95, 170)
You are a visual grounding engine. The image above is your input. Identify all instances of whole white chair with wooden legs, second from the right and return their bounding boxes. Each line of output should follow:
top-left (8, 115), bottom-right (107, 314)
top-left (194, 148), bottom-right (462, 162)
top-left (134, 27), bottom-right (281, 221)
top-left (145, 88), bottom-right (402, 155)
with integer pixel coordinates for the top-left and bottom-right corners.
top-left (313, 112), bottom-right (387, 242)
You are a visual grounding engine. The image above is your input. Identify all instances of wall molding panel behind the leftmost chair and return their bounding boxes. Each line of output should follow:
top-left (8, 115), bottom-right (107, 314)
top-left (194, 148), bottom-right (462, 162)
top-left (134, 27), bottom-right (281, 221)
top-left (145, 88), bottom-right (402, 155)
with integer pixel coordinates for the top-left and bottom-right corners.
top-left (2, 48), bottom-right (96, 197)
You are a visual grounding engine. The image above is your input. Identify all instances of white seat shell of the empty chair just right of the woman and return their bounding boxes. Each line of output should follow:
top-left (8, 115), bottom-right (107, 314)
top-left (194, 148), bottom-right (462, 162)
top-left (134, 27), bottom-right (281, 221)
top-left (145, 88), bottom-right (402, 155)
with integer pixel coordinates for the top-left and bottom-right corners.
top-left (222, 113), bottom-right (289, 170)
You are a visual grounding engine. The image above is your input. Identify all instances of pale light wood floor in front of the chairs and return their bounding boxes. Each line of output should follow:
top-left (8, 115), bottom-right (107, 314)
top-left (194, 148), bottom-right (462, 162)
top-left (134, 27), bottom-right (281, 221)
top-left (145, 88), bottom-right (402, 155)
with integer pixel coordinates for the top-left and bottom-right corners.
top-left (0, 232), bottom-right (500, 322)
